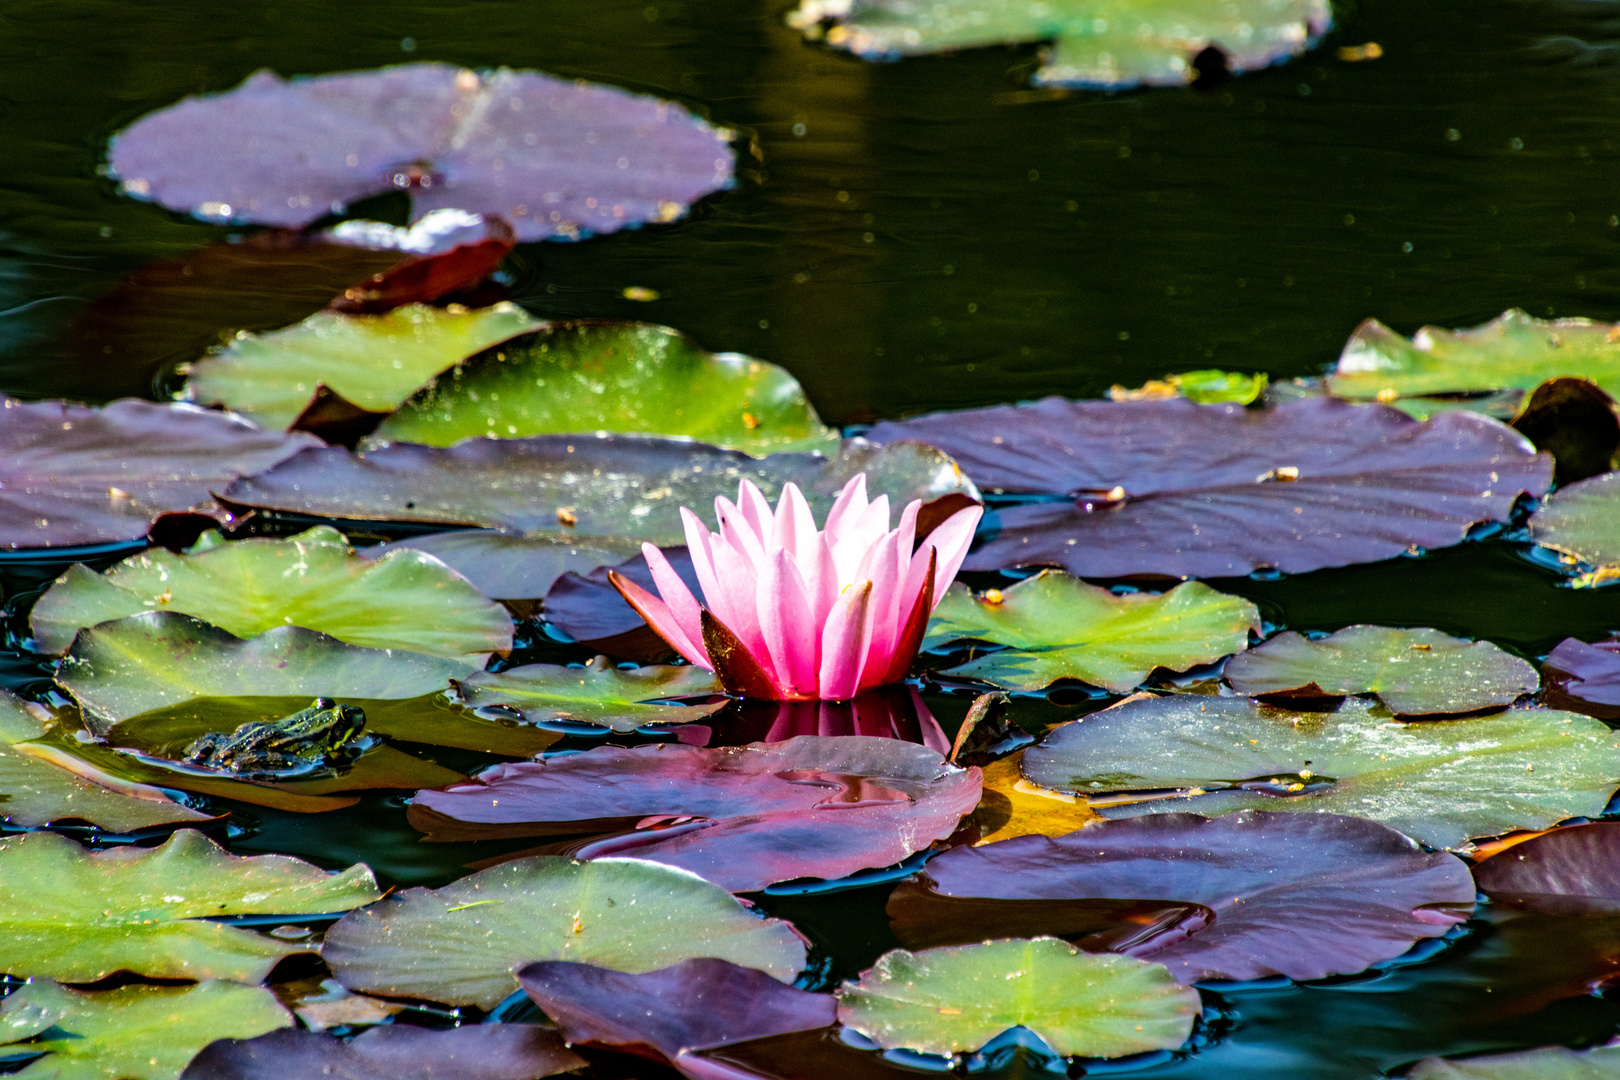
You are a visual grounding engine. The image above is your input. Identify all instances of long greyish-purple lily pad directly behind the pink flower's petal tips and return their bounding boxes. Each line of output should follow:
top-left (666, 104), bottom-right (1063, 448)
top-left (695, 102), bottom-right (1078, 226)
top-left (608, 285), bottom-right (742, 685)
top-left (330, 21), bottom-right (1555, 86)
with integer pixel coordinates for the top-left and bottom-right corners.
top-left (224, 434), bottom-right (978, 544)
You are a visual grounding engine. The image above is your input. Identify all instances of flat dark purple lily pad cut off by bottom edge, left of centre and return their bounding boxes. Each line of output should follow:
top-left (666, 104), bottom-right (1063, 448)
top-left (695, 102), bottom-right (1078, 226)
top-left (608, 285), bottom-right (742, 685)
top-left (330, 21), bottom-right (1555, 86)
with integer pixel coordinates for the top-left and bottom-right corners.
top-left (180, 1023), bottom-right (586, 1080)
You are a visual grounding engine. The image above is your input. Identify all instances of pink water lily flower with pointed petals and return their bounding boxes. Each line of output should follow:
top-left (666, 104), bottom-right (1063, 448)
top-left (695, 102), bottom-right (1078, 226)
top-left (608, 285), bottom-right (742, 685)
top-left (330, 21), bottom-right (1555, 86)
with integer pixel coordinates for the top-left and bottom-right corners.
top-left (609, 473), bottom-right (983, 701)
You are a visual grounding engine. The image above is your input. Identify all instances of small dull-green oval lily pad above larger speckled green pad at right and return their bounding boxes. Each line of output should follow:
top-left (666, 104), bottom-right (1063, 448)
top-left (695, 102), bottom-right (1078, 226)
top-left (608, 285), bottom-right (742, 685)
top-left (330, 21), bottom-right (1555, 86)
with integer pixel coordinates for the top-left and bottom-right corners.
top-left (1225, 627), bottom-right (1541, 716)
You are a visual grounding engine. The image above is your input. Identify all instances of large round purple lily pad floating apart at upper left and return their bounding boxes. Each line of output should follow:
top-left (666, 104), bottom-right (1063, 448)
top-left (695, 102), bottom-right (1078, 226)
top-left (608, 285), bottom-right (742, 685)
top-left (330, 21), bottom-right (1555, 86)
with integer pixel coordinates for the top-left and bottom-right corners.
top-left (107, 63), bottom-right (734, 241)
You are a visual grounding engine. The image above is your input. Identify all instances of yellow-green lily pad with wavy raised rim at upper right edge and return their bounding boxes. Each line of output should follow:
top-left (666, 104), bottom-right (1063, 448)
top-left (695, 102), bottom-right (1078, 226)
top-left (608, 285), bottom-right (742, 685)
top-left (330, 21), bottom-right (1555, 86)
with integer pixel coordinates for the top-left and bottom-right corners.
top-left (1327, 308), bottom-right (1620, 417)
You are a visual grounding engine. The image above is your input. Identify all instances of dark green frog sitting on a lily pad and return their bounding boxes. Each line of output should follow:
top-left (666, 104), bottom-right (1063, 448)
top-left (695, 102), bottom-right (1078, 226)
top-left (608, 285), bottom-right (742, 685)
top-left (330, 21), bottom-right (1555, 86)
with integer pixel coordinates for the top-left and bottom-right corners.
top-left (183, 698), bottom-right (366, 777)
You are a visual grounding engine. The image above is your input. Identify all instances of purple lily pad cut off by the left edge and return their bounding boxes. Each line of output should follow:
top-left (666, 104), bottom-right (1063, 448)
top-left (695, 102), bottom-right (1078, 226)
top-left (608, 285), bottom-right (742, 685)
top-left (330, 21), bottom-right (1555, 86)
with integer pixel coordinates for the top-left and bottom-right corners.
top-left (0, 397), bottom-right (321, 549)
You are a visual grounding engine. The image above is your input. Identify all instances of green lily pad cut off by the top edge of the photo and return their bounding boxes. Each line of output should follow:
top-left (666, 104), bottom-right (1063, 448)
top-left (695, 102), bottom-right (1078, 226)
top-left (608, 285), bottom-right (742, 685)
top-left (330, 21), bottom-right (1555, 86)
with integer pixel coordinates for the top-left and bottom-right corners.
top-left (787, 0), bottom-right (1333, 89)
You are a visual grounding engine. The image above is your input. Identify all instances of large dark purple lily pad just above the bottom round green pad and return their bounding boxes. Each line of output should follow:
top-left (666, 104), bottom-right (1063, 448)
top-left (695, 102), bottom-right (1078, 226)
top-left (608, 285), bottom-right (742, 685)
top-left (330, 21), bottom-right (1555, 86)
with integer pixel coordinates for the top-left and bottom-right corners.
top-left (889, 810), bottom-right (1474, 983)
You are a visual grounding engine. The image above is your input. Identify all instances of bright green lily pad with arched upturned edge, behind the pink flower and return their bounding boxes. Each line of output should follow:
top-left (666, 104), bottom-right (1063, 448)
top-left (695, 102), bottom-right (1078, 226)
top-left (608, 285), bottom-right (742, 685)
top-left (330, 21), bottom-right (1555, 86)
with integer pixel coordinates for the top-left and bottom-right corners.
top-left (361, 322), bottom-right (838, 453)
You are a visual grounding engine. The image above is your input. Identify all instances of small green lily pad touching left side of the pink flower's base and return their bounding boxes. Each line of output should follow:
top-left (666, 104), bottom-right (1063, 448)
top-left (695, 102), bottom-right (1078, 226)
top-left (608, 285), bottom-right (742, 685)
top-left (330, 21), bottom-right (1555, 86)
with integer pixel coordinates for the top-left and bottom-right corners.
top-left (455, 656), bottom-right (726, 732)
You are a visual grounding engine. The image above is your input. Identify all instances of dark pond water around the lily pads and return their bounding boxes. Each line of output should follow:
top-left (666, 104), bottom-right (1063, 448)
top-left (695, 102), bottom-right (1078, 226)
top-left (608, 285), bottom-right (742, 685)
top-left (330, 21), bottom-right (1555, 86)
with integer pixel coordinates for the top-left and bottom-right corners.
top-left (0, 0), bottom-right (1620, 1080)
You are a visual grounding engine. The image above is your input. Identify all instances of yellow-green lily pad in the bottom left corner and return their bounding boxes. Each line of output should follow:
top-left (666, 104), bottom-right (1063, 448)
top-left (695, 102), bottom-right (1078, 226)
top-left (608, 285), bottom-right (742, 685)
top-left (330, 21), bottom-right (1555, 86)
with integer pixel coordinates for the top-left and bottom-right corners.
top-left (0, 980), bottom-right (293, 1080)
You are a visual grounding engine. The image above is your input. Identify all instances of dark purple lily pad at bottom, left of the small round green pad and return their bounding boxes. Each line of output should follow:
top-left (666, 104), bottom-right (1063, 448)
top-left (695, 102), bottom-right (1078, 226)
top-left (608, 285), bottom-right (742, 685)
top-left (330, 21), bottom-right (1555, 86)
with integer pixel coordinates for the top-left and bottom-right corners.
top-left (517, 959), bottom-right (838, 1080)
